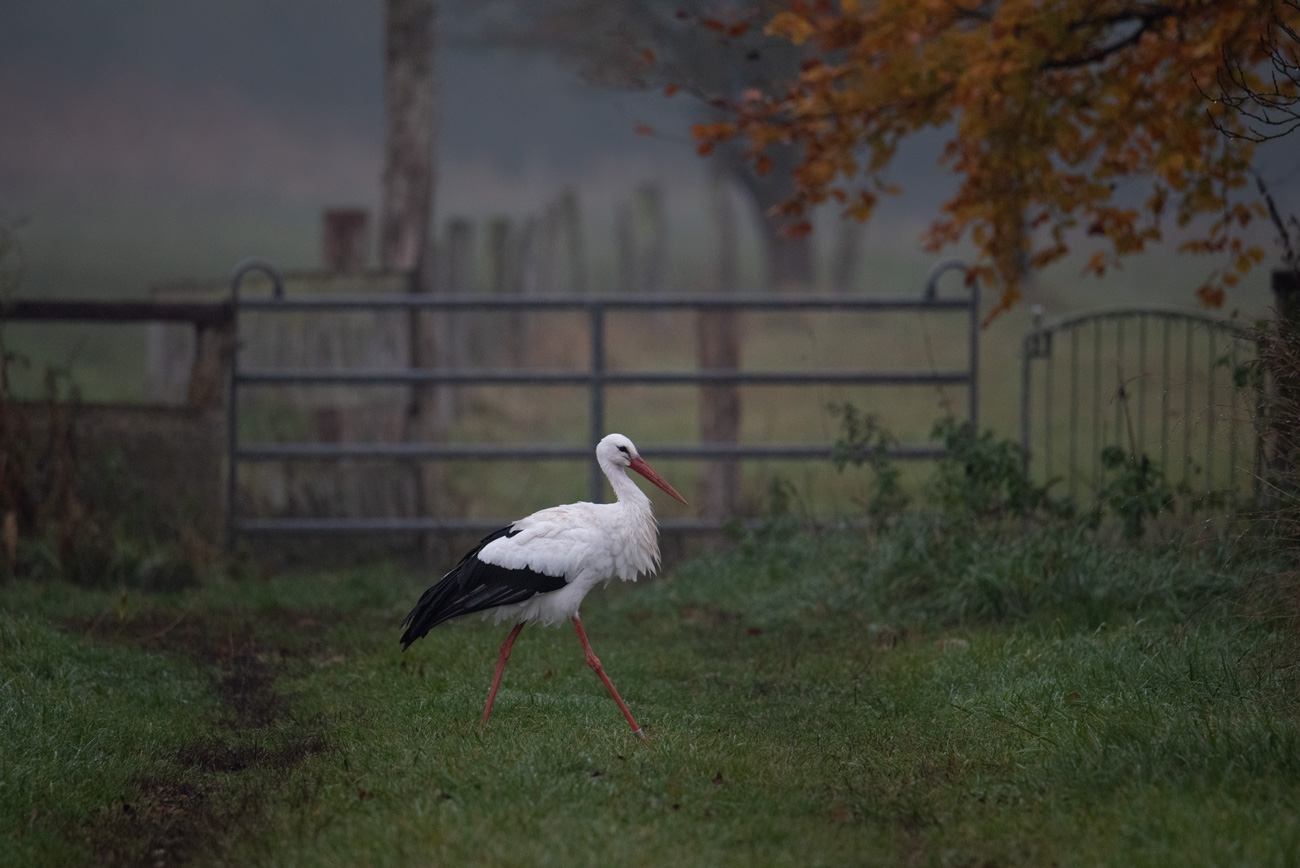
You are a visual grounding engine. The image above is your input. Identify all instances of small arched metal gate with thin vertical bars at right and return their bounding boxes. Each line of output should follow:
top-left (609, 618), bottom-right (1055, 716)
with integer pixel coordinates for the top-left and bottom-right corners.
top-left (1021, 305), bottom-right (1264, 503)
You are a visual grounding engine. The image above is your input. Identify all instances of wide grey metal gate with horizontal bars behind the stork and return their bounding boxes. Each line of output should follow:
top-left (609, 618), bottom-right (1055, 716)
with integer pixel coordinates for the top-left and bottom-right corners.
top-left (226, 260), bottom-right (979, 544)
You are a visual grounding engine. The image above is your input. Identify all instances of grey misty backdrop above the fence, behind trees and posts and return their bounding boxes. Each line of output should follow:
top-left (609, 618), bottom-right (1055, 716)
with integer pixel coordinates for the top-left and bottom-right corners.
top-left (0, 0), bottom-right (1300, 317)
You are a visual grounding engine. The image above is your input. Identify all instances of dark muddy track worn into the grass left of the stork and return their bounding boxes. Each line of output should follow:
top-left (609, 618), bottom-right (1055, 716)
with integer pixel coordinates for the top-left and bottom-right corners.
top-left (69, 612), bottom-right (330, 868)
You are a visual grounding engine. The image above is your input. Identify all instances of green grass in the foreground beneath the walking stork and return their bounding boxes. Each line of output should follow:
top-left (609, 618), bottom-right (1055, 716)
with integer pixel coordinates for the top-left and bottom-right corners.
top-left (0, 518), bottom-right (1300, 865)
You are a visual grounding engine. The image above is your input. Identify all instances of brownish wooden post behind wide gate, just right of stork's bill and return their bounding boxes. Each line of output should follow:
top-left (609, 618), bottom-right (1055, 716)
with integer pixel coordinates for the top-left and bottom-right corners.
top-left (698, 175), bottom-right (741, 516)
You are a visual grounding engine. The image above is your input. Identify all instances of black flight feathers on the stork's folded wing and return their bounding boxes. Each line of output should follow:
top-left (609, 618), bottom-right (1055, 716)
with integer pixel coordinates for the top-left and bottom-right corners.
top-left (400, 526), bottom-right (564, 651)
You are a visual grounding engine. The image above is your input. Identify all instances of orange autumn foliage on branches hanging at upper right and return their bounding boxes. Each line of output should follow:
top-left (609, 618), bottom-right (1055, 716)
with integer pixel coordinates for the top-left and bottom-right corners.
top-left (696, 0), bottom-right (1279, 316)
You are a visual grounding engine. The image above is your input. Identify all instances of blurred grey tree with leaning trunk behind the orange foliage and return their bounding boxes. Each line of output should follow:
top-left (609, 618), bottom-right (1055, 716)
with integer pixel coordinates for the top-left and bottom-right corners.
top-left (482, 0), bottom-right (814, 288)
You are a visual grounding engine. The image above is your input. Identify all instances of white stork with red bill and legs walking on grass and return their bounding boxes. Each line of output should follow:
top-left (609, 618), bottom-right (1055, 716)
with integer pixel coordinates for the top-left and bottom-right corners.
top-left (402, 434), bottom-right (686, 738)
